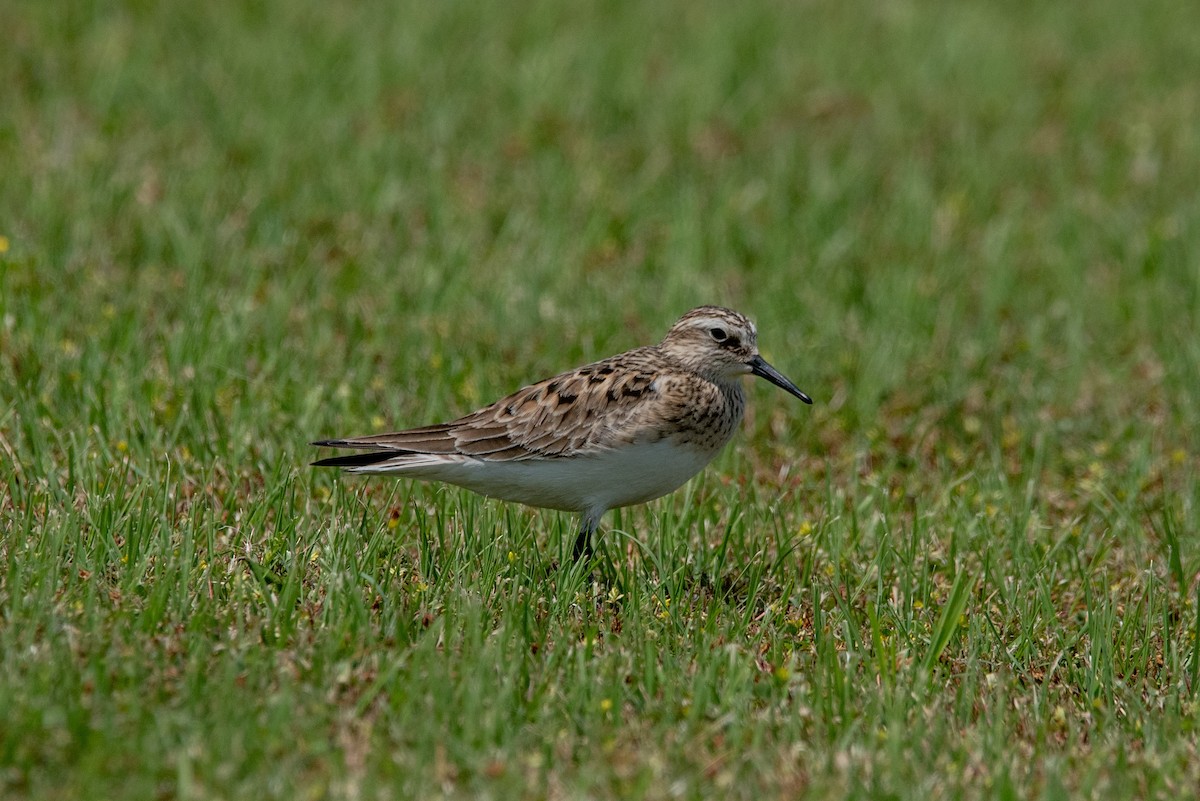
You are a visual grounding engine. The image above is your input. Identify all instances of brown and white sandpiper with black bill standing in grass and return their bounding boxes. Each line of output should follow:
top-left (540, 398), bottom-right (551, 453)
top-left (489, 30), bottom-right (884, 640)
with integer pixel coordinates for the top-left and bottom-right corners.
top-left (312, 306), bottom-right (812, 561)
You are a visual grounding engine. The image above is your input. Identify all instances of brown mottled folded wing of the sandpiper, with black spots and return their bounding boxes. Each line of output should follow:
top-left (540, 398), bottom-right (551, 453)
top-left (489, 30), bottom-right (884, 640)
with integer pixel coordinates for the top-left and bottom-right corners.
top-left (323, 349), bottom-right (664, 459)
